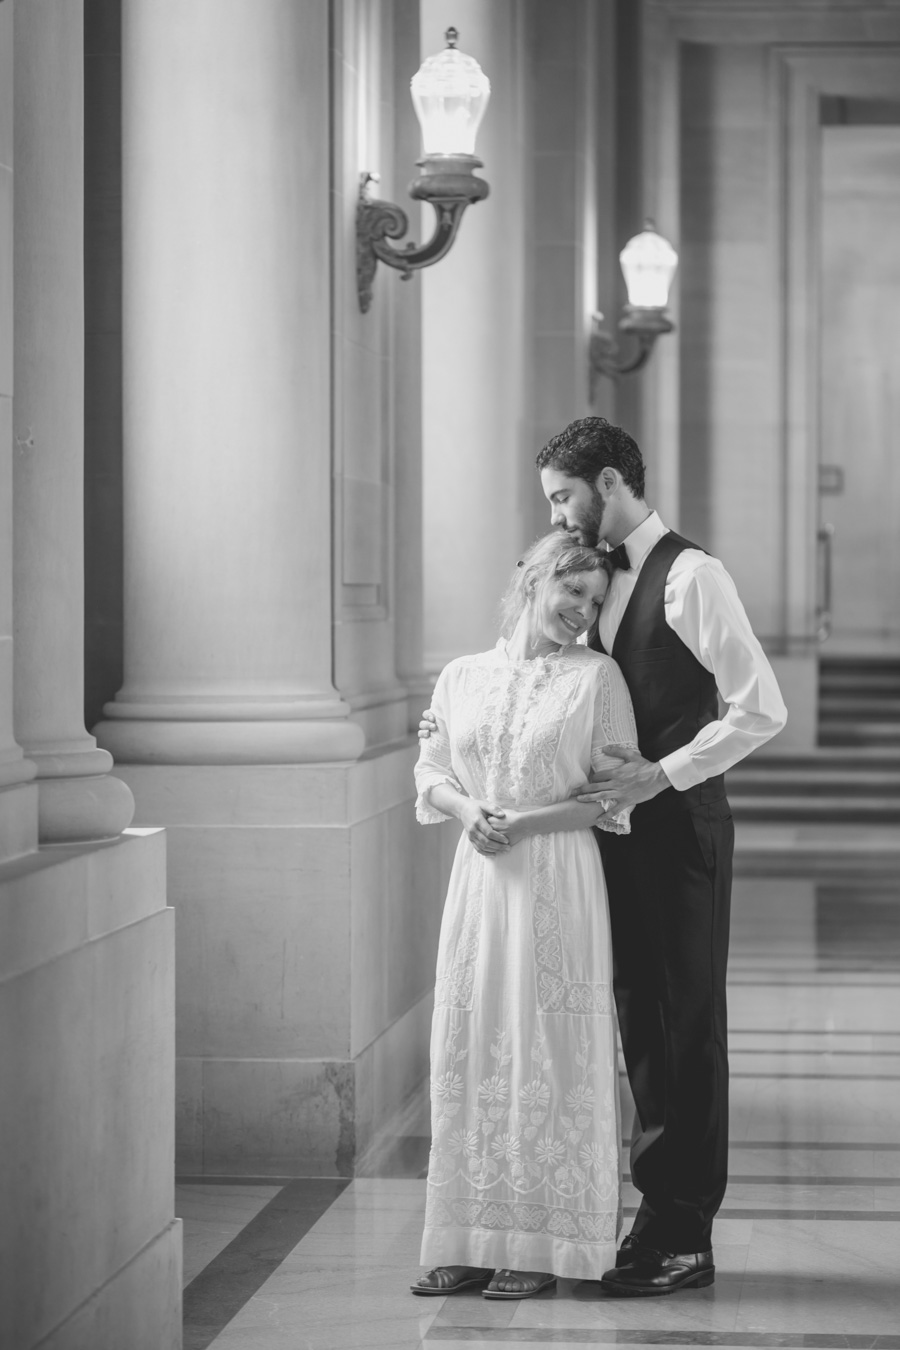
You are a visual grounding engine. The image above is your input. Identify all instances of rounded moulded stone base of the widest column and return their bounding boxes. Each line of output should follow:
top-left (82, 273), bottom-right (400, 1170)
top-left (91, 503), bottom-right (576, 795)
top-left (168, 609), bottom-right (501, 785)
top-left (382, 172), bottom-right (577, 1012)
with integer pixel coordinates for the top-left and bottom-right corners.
top-left (93, 705), bottom-right (366, 764)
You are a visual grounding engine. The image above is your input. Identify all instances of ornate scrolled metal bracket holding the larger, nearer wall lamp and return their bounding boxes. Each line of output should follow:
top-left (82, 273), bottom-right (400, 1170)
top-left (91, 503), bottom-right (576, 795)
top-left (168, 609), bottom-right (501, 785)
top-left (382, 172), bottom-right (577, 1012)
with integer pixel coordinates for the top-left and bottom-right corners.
top-left (356, 155), bottom-right (490, 313)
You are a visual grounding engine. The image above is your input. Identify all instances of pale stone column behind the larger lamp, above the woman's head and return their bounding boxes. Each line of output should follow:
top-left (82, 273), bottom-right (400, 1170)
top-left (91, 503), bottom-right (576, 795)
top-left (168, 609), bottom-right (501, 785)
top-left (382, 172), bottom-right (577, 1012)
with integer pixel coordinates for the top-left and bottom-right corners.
top-left (421, 0), bottom-right (531, 671)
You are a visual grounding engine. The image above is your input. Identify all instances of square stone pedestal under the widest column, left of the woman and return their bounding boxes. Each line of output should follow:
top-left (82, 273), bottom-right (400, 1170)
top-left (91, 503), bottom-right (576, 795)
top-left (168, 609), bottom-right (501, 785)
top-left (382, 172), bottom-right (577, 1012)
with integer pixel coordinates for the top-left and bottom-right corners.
top-left (117, 737), bottom-right (459, 1176)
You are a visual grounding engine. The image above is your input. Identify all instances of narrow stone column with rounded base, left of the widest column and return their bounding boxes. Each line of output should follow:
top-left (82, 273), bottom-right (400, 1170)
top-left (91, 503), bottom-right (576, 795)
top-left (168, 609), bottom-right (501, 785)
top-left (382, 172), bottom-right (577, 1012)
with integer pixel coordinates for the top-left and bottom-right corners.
top-left (12, 0), bottom-right (134, 844)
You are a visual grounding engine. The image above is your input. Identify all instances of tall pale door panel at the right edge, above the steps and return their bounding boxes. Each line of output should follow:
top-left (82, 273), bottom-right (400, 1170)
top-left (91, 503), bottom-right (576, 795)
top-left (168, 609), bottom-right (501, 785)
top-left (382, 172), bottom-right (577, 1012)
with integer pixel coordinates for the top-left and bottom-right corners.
top-left (819, 118), bottom-right (900, 656)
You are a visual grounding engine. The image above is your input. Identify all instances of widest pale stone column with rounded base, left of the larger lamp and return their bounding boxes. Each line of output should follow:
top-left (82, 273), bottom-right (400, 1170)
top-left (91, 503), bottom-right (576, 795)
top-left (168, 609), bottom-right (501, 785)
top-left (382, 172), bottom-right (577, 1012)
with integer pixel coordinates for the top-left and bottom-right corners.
top-left (97, 0), bottom-right (363, 764)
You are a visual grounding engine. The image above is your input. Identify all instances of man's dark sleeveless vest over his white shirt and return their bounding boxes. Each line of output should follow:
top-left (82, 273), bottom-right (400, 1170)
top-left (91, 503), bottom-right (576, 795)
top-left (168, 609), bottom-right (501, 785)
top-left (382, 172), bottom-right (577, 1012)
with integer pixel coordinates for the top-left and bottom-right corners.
top-left (594, 532), bottom-right (725, 806)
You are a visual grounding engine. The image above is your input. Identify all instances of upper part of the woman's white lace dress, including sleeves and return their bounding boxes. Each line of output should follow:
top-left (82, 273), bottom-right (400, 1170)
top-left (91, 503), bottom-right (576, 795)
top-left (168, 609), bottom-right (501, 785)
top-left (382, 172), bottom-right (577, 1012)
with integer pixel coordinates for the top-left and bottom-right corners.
top-left (416, 640), bottom-right (637, 830)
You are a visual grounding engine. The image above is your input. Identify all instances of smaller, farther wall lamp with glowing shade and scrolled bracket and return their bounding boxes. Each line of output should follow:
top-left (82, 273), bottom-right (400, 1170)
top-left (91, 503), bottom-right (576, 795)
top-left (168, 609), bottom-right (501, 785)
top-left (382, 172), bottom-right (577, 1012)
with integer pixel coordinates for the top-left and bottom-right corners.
top-left (588, 220), bottom-right (679, 391)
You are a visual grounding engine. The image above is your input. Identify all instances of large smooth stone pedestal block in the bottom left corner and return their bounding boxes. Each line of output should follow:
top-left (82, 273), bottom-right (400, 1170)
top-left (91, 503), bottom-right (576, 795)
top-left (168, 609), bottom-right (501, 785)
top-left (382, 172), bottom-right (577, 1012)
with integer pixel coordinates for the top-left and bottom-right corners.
top-left (0, 830), bottom-right (181, 1350)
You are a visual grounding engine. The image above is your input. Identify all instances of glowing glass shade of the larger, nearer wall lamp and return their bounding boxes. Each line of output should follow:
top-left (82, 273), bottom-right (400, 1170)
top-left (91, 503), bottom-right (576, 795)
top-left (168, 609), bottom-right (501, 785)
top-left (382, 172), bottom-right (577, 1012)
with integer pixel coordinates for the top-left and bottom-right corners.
top-left (410, 28), bottom-right (491, 155)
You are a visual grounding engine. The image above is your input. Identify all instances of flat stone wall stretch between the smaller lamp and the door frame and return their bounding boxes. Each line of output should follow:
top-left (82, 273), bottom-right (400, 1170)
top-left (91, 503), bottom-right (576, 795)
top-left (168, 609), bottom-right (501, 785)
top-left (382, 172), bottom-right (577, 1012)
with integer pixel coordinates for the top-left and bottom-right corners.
top-left (680, 43), bottom-right (784, 629)
